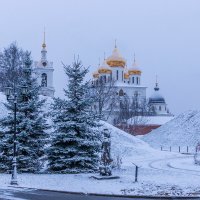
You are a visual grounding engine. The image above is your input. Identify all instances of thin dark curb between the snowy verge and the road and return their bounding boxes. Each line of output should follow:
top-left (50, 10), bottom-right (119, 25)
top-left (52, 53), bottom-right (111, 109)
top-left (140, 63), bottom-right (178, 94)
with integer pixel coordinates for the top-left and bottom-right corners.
top-left (8, 186), bottom-right (200, 199)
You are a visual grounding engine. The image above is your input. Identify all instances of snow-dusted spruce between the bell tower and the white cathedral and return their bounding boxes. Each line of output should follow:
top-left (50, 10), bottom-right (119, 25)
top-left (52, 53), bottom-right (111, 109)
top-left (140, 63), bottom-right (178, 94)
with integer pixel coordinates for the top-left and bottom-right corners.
top-left (48, 60), bottom-right (100, 173)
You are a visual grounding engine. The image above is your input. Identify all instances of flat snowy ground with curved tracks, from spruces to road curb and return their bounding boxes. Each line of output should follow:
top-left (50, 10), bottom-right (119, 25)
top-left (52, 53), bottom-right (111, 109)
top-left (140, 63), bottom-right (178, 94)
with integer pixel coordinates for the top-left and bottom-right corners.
top-left (0, 155), bottom-right (200, 196)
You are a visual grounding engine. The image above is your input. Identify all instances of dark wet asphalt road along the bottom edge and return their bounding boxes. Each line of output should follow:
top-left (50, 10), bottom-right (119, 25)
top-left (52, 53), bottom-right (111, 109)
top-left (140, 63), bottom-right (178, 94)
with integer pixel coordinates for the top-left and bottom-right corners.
top-left (0, 189), bottom-right (200, 200)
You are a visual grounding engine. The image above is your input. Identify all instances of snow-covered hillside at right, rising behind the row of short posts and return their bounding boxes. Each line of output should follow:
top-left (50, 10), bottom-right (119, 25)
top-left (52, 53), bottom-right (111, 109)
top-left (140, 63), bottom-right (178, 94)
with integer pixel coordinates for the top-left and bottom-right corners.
top-left (142, 110), bottom-right (200, 148)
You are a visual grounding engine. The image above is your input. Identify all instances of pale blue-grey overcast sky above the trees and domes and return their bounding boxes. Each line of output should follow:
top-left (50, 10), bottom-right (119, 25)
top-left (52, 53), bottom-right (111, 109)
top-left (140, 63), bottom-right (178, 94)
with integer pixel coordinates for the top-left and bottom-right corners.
top-left (0, 0), bottom-right (200, 114)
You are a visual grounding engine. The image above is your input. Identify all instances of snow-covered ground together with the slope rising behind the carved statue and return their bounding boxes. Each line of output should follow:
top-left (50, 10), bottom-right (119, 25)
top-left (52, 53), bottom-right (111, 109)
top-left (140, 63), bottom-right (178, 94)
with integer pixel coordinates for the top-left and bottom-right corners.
top-left (0, 123), bottom-right (200, 196)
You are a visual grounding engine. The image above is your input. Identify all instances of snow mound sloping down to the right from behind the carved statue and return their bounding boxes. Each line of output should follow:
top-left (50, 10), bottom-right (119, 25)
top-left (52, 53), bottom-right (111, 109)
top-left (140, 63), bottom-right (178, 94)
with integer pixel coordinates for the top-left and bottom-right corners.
top-left (102, 122), bottom-right (159, 166)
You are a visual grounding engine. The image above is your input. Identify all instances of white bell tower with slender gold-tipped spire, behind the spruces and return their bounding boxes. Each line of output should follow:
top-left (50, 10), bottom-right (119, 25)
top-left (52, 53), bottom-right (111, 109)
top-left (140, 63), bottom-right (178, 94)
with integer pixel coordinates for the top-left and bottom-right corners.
top-left (34, 31), bottom-right (55, 97)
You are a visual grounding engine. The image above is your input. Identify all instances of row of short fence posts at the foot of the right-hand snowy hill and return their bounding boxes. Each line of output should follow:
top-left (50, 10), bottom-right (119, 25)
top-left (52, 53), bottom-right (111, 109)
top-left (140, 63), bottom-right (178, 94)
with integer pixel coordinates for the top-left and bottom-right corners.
top-left (160, 146), bottom-right (197, 154)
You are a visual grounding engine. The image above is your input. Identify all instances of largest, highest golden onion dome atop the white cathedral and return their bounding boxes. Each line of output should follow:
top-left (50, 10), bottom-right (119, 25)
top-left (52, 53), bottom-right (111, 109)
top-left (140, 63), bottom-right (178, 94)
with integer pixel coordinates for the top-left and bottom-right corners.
top-left (107, 46), bottom-right (126, 67)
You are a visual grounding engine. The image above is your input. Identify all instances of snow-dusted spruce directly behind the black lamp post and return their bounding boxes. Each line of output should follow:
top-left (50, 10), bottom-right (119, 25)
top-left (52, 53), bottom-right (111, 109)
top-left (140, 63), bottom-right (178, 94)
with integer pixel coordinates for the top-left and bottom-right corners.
top-left (0, 52), bottom-right (48, 173)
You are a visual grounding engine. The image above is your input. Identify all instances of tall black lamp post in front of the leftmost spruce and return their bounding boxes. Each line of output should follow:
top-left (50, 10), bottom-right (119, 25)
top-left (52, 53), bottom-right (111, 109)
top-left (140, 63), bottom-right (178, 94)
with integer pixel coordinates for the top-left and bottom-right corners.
top-left (5, 85), bottom-right (28, 185)
